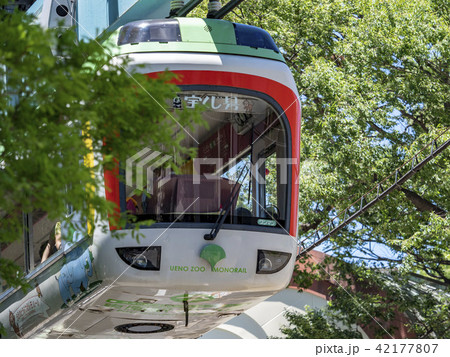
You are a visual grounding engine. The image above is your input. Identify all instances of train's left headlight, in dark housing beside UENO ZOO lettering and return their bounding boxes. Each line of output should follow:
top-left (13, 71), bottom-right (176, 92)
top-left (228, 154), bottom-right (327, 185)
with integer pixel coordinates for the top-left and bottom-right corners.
top-left (116, 247), bottom-right (161, 270)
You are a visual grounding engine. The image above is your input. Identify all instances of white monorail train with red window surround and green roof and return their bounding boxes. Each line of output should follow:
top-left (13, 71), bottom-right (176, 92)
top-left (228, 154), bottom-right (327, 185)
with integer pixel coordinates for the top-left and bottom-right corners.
top-left (0, 18), bottom-right (300, 338)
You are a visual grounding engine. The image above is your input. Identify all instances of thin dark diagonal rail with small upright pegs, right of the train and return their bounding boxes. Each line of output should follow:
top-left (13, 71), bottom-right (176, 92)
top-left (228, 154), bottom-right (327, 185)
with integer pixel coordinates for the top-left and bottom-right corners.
top-left (297, 134), bottom-right (450, 258)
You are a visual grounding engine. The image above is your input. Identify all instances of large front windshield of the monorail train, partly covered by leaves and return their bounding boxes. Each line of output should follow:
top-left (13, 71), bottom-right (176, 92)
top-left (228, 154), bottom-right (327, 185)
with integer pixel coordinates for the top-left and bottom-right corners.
top-left (122, 91), bottom-right (291, 228)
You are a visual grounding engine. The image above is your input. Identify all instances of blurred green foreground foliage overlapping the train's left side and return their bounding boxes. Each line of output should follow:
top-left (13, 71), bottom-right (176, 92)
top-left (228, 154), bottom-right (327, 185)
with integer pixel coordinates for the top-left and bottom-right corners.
top-left (0, 5), bottom-right (198, 286)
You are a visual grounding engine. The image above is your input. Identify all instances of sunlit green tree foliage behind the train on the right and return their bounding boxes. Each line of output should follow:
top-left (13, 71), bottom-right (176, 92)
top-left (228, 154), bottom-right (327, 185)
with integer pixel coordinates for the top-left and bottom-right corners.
top-left (223, 0), bottom-right (450, 338)
